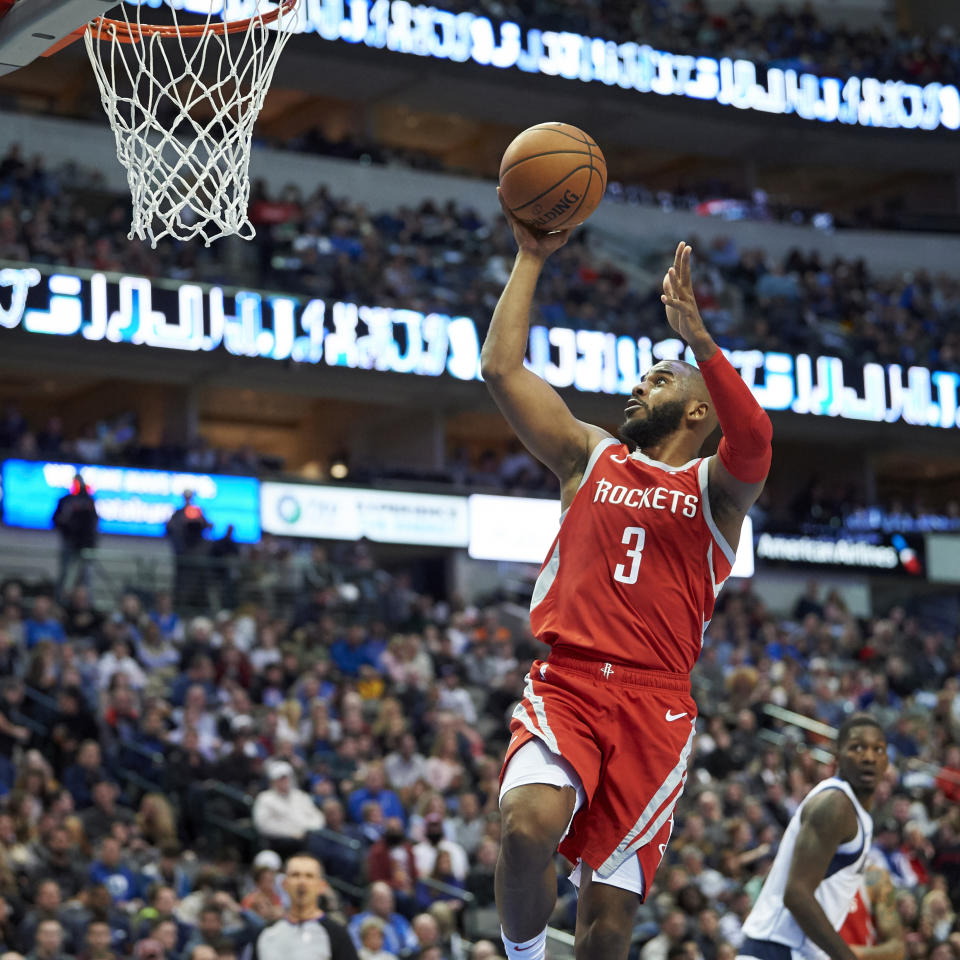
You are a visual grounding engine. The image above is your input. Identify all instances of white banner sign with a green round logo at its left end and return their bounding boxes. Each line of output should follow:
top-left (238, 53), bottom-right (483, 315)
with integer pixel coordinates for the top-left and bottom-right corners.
top-left (260, 481), bottom-right (470, 547)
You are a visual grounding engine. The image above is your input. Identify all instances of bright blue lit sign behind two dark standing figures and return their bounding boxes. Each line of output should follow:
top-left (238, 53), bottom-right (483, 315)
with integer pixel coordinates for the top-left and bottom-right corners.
top-left (3, 460), bottom-right (260, 543)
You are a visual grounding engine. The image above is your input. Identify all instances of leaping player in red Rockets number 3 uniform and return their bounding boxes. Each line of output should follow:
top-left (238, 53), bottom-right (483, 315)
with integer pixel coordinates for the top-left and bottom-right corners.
top-left (482, 197), bottom-right (772, 960)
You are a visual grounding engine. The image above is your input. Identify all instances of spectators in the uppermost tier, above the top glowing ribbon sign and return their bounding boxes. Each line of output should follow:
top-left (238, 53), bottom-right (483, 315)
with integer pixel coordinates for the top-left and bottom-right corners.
top-left (452, 0), bottom-right (960, 84)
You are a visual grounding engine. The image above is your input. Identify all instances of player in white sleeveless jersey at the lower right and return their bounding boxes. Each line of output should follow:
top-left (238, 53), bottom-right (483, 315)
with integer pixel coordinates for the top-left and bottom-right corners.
top-left (739, 713), bottom-right (887, 960)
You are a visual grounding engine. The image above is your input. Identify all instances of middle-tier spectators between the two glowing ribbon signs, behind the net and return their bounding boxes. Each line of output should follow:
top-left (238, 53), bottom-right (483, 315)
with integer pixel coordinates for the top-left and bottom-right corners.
top-left (0, 144), bottom-right (960, 370)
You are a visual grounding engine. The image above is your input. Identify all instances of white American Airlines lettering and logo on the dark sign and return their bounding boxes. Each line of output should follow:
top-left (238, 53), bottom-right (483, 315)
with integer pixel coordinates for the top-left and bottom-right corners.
top-left (756, 533), bottom-right (923, 576)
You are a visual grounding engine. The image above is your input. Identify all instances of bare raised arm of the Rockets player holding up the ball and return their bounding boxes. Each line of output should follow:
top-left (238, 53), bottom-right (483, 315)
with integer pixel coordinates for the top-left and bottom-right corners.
top-left (480, 192), bottom-right (608, 500)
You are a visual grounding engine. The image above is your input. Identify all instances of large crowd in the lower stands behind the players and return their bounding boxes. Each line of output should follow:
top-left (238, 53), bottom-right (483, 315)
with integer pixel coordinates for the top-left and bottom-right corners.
top-left (0, 542), bottom-right (960, 960)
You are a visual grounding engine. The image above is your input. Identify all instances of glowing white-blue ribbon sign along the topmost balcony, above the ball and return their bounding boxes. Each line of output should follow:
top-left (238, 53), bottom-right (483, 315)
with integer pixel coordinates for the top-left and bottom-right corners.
top-left (143, 0), bottom-right (960, 130)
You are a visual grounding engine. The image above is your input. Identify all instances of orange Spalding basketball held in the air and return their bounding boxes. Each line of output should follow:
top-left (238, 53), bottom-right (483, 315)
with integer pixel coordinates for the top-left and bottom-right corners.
top-left (500, 122), bottom-right (607, 231)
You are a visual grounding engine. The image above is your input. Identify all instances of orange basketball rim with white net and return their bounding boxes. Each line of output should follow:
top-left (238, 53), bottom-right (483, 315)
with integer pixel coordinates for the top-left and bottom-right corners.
top-left (83, 0), bottom-right (297, 247)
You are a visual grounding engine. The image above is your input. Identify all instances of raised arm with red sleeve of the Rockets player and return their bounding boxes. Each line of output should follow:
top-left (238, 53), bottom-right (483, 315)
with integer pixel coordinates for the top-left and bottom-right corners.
top-left (660, 243), bottom-right (773, 546)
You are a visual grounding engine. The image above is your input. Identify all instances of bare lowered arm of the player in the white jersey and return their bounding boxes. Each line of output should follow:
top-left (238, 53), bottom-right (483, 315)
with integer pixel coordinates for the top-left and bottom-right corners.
top-left (783, 790), bottom-right (857, 960)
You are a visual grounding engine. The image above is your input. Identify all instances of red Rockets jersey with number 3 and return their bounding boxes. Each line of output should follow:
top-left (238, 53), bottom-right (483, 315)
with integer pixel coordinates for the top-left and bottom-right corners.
top-left (530, 438), bottom-right (735, 673)
